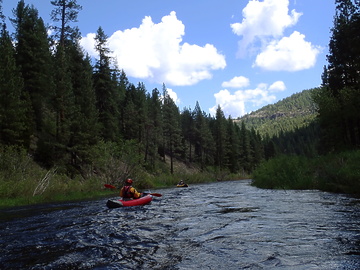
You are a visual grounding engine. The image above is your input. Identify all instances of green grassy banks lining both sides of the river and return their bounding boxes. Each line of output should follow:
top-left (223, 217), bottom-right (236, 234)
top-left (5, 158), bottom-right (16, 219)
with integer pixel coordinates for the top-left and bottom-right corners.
top-left (0, 151), bottom-right (360, 208)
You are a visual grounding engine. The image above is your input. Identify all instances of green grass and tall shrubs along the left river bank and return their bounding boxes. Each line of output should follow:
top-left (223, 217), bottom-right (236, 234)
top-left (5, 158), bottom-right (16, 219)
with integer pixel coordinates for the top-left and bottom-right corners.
top-left (0, 148), bottom-right (246, 208)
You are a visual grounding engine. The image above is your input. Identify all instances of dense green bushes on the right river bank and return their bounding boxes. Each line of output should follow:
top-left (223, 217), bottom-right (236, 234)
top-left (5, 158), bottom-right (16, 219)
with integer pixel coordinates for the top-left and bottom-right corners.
top-left (253, 151), bottom-right (360, 195)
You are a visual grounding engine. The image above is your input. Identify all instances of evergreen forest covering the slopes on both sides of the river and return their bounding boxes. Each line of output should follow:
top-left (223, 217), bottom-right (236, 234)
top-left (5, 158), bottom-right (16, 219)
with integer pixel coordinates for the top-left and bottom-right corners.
top-left (0, 0), bottom-right (360, 205)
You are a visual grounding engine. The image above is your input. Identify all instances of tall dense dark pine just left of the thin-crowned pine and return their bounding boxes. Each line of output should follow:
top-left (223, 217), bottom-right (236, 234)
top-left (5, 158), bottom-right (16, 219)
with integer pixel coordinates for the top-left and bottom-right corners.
top-left (11, 0), bottom-right (54, 143)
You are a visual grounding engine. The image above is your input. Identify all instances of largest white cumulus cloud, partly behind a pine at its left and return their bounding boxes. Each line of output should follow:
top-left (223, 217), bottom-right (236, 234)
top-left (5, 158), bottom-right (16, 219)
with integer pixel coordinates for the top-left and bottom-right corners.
top-left (81, 11), bottom-right (226, 86)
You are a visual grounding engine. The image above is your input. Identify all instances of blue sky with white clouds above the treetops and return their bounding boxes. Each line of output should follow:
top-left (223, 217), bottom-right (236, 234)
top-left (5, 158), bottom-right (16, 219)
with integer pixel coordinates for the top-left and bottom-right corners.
top-left (3, 0), bottom-right (335, 118)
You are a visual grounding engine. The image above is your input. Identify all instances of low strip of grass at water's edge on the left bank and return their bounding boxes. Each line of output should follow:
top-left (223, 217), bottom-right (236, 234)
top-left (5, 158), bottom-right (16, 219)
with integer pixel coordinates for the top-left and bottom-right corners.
top-left (0, 169), bottom-right (248, 208)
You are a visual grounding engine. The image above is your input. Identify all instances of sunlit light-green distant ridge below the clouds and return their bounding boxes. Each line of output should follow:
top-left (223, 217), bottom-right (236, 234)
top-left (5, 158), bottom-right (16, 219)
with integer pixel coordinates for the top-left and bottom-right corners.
top-left (234, 88), bottom-right (317, 137)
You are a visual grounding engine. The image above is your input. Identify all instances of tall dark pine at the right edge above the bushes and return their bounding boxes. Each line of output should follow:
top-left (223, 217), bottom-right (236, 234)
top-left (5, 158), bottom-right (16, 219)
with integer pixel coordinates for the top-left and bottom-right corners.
top-left (315, 0), bottom-right (360, 151)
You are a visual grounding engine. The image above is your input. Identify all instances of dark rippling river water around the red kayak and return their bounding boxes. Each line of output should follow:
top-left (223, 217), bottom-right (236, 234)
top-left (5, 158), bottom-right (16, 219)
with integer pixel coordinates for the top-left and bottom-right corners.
top-left (0, 180), bottom-right (360, 270)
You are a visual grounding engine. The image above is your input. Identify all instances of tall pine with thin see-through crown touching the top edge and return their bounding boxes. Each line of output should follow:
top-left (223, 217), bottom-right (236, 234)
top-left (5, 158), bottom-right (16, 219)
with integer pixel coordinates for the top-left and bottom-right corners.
top-left (51, 0), bottom-right (81, 166)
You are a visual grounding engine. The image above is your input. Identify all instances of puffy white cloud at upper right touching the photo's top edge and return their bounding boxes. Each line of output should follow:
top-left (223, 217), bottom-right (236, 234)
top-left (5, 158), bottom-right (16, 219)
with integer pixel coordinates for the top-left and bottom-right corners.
top-left (231, 0), bottom-right (322, 71)
